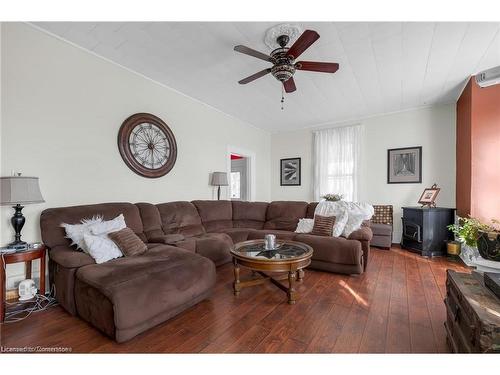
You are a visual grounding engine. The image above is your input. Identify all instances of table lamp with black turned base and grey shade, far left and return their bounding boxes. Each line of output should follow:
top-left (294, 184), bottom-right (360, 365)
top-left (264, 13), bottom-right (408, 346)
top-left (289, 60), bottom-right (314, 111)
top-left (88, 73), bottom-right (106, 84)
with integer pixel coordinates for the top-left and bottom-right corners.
top-left (0, 175), bottom-right (45, 248)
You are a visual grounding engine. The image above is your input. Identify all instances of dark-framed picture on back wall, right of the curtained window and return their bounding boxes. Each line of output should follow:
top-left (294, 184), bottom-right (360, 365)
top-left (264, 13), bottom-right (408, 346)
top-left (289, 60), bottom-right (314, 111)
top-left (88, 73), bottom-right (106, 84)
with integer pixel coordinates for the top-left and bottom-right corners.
top-left (387, 146), bottom-right (422, 184)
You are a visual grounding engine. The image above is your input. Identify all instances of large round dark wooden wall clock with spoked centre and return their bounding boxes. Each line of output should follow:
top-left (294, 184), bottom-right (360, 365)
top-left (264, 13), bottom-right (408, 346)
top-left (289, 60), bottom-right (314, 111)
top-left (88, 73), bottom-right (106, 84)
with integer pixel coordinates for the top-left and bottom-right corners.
top-left (118, 113), bottom-right (177, 178)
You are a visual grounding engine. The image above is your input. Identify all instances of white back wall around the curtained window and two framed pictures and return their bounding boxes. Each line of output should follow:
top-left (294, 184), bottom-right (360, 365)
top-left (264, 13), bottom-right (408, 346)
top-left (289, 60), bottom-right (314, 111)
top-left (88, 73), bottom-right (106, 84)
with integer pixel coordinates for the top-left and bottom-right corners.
top-left (271, 104), bottom-right (455, 242)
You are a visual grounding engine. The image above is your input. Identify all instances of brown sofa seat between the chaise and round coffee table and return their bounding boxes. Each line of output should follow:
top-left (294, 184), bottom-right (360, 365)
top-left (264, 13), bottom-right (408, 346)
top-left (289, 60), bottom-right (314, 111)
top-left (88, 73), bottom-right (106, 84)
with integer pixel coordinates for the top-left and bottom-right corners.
top-left (194, 233), bottom-right (233, 266)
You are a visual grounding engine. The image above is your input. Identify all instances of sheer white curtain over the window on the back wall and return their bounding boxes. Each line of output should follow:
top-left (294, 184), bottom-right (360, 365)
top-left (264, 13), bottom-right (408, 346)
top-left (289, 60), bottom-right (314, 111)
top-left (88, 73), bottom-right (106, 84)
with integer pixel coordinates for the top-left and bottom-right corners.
top-left (314, 125), bottom-right (362, 201)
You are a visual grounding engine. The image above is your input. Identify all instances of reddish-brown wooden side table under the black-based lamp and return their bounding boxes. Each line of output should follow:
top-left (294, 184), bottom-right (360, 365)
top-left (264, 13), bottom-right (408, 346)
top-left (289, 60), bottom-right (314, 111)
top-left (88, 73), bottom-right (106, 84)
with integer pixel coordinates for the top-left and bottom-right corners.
top-left (0, 245), bottom-right (47, 323)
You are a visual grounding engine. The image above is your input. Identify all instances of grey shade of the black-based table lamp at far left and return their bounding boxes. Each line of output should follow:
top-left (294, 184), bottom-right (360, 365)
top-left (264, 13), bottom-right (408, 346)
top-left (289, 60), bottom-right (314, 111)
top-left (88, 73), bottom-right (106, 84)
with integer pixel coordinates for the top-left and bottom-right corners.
top-left (0, 176), bottom-right (45, 206)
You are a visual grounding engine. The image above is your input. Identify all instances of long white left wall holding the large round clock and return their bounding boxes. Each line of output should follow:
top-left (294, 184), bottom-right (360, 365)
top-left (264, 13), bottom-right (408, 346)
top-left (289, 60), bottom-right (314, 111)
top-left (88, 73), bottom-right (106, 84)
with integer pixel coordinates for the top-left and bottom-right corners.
top-left (0, 23), bottom-right (270, 287)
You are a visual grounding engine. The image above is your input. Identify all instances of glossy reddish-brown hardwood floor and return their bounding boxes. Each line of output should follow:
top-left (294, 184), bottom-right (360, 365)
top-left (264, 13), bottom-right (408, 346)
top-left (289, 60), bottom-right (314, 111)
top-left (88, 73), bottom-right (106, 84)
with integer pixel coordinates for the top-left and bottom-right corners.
top-left (0, 249), bottom-right (467, 353)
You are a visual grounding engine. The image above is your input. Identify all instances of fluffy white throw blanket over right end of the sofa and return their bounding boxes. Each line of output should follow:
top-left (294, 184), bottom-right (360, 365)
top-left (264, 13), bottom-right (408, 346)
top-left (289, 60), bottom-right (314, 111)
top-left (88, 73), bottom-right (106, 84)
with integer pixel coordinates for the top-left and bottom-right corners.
top-left (314, 201), bottom-right (375, 237)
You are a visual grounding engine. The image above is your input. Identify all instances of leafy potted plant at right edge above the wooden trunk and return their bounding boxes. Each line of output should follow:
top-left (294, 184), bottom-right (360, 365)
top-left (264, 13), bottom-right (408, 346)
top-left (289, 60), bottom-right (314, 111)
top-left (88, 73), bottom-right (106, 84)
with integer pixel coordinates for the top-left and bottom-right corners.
top-left (448, 217), bottom-right (500, 261)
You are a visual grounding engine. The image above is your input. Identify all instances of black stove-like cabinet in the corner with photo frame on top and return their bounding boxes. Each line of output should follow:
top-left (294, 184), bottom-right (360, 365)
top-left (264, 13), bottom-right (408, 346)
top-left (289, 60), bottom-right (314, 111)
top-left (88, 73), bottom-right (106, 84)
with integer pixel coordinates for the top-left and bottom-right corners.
top-left (401, 207), bottom-right (455, 256)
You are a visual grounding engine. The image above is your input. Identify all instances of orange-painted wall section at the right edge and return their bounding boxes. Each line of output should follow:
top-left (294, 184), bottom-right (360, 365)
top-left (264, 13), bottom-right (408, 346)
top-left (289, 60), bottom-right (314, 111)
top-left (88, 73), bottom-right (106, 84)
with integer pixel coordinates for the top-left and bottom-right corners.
top-left (457, 78), bottom-right (500, 221)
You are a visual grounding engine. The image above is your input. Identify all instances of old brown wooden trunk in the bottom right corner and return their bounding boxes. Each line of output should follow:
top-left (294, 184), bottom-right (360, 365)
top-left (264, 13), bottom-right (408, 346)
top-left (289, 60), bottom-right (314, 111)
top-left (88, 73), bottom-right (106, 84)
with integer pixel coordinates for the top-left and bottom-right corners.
top-left (444, 270), bottom-right (500, 353)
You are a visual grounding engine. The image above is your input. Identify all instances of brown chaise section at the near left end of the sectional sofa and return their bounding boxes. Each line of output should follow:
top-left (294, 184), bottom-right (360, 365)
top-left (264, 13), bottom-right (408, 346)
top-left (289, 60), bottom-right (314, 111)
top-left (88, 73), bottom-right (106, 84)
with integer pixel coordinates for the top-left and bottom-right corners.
top-left (40, 203), bottom-right (215, 342)
